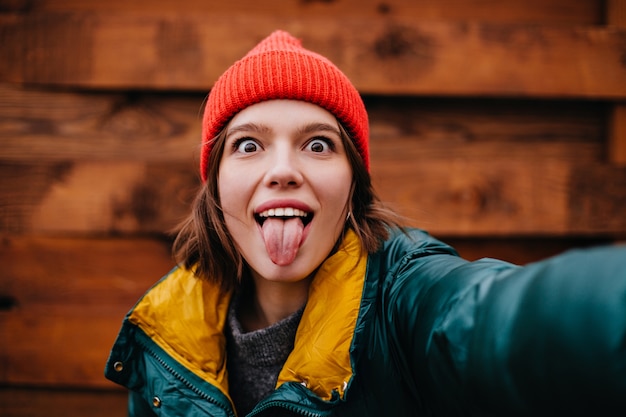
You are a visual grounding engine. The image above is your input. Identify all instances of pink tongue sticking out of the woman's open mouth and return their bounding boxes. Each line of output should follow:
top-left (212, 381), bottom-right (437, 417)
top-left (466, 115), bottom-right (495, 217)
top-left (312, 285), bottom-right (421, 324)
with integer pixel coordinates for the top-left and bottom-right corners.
top-left (263, 218), bottom-right (304, 266)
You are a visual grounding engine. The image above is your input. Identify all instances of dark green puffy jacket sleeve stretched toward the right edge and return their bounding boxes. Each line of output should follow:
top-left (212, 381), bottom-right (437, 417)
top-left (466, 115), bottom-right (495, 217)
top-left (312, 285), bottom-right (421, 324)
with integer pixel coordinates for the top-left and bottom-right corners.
top-left (391, 242), bottom-right (626, 415)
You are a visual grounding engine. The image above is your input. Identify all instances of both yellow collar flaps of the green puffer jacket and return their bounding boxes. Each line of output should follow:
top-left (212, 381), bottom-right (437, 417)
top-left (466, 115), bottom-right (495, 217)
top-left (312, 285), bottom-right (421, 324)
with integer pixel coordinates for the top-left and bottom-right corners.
top-left (129, 230), bottom-right (367, 400)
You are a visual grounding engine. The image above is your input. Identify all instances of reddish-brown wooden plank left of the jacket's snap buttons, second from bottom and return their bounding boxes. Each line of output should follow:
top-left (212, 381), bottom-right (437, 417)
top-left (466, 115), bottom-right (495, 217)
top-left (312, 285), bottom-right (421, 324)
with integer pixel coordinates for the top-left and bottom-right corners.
top-left (0, 305), bottom-right (125, 388)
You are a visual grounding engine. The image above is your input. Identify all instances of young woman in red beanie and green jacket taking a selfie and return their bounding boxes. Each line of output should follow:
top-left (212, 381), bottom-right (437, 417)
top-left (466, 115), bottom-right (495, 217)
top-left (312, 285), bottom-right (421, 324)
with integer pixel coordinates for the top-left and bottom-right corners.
top-left (106, 31), bottom-right (626, 417)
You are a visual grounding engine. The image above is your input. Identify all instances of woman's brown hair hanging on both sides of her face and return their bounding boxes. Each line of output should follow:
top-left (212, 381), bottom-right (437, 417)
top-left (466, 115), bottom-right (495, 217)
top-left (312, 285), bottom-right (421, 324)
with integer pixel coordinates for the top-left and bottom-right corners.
top-left (173, 124), bottom-right (402, 291)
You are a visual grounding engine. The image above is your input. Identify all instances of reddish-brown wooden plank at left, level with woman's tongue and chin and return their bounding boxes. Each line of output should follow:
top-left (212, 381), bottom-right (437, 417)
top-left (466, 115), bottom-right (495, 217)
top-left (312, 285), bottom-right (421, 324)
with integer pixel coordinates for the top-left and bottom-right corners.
top-left (0, 235), bottom-right (174, 308)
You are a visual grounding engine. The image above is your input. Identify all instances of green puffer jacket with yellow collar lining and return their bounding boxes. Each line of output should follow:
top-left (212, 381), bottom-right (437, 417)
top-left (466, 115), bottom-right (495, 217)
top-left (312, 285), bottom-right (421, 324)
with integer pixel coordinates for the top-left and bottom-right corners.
top-left (105, 230), bottom-right (626, 417)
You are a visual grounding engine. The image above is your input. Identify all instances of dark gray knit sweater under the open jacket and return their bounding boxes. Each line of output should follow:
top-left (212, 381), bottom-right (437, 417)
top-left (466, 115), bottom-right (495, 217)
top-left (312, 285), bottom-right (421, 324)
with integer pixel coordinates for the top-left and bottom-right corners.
top-left (225, 298), bottom-right (304, 416)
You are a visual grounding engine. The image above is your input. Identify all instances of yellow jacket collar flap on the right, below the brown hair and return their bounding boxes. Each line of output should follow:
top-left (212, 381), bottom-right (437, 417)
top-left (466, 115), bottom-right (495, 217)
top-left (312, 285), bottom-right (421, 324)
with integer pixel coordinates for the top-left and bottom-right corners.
top-left (277, 230), bottom-right (367, 400)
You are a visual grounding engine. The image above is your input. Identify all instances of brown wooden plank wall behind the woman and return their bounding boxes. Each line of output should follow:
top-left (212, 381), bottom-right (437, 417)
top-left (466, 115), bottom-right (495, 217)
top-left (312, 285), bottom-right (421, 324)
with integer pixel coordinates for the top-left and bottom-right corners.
top-left (0, 0), bottom-right (626, 417)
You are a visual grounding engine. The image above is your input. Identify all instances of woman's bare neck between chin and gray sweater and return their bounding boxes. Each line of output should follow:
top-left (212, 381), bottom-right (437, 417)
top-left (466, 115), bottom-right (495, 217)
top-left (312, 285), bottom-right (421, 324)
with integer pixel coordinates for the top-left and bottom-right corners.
top-left (239, 277), bottom-right (311, 332)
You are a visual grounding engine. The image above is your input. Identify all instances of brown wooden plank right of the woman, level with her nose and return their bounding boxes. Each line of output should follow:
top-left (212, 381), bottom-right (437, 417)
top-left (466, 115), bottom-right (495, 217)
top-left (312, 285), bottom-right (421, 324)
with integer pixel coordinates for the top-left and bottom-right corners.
top-left (372, 159), bottom-right (626, 236)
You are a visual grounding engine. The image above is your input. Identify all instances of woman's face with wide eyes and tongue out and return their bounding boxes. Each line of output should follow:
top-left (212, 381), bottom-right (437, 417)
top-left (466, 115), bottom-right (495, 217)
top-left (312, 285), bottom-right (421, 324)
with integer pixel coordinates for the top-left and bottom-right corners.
top-left (218, 100), bottom-right (352, 282)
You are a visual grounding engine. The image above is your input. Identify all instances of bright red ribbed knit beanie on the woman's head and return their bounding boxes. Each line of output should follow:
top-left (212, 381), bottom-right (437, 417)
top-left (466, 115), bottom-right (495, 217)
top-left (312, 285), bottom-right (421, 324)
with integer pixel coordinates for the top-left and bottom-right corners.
top-left (200, 30), bottom-right (369, 181)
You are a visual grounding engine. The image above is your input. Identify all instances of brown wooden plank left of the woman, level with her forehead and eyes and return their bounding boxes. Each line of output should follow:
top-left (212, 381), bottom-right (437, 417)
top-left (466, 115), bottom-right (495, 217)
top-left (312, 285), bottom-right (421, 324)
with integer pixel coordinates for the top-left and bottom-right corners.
top-left (0, 84), bottom-right (203, 163)
